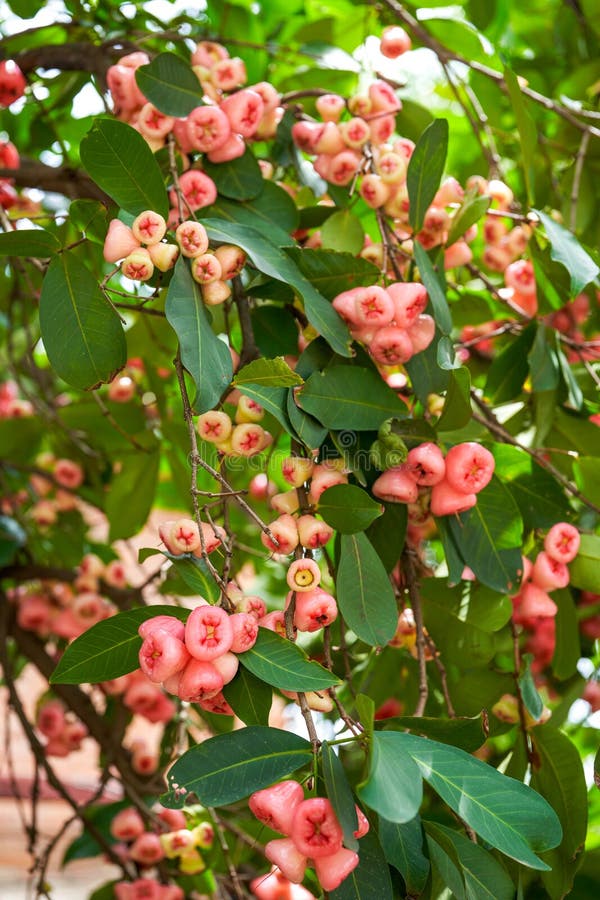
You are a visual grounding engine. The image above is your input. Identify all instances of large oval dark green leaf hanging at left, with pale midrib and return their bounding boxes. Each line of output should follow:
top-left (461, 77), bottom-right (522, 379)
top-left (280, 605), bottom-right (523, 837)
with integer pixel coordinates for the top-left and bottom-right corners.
top-left (40, 253), bottom-right (127, 390)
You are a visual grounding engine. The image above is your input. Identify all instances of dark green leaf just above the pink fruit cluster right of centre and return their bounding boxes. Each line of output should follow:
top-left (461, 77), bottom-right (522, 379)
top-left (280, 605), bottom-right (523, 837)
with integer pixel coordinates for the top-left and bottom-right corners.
top-left (286, 247), bottom-right (380, 300)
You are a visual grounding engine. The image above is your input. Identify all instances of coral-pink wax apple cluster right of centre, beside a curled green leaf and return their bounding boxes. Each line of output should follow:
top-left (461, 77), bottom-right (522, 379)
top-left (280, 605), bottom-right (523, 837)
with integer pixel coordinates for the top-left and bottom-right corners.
top-left (372, 441), bottom-right (495, 522)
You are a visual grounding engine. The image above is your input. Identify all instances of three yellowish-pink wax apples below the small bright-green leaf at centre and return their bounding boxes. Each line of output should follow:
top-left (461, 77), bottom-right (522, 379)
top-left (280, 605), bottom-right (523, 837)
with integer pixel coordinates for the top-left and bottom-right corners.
top-left (196, 394), bottom-right (273, 456)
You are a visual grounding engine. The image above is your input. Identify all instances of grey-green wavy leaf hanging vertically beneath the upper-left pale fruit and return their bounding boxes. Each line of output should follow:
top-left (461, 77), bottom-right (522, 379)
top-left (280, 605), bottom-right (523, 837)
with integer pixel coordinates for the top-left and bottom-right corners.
top-left (165, 258), bottom-right (233, 413)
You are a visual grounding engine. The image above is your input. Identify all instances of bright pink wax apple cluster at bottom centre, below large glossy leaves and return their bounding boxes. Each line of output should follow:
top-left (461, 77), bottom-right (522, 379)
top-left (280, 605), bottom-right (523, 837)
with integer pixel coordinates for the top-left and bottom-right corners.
top-left (248, 780), bottom-right (369, 891)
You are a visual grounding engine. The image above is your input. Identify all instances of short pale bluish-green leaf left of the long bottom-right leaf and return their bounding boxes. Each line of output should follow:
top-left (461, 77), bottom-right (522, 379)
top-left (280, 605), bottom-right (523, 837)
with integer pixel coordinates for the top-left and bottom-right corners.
top-left (357, 731), bottom-right (423, 822)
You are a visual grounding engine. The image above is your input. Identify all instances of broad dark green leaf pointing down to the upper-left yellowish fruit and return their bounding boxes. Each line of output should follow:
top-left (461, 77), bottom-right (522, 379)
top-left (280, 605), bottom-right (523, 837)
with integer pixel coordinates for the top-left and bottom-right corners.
top-left (80, 118), bottom-right (169, 217)
